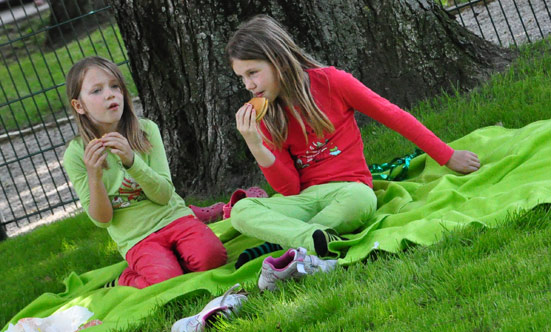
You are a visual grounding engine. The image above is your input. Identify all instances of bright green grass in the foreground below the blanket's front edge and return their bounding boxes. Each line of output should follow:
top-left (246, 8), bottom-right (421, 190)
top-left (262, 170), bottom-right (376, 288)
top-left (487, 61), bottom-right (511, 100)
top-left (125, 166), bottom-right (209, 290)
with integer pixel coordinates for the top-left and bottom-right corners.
top-left (110, 206), bottom-right (551, 332)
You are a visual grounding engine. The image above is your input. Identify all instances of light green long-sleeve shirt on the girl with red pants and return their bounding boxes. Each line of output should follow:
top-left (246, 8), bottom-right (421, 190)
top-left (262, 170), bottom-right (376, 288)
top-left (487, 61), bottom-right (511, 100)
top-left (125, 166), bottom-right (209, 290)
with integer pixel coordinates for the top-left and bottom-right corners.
top-left (63, 119), bottom-right (193, 257)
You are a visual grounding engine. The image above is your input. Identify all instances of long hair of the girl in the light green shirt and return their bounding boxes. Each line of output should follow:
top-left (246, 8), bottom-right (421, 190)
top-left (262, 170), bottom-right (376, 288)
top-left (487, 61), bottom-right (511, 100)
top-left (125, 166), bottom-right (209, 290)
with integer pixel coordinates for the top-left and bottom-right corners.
top-left (66, 56), bottom-right (151, 158)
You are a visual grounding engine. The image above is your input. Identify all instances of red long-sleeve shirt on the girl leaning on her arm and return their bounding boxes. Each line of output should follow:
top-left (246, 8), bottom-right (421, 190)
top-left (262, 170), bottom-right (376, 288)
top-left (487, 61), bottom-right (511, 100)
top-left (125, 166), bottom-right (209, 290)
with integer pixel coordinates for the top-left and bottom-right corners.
top-left (261, 67), bottom-right (454, 196)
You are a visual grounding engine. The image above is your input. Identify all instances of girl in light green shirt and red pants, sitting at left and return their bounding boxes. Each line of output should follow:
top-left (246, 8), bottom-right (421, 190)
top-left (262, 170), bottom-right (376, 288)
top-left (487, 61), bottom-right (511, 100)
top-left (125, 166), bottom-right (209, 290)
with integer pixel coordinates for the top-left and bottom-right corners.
top-left (63, 56), bottom-right (227, 288)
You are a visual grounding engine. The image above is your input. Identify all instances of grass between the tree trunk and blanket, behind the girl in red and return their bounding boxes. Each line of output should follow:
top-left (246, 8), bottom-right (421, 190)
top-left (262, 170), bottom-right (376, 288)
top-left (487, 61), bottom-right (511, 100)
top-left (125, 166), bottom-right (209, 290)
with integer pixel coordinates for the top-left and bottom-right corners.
top-left (362, 40), bottom-right (551, 164)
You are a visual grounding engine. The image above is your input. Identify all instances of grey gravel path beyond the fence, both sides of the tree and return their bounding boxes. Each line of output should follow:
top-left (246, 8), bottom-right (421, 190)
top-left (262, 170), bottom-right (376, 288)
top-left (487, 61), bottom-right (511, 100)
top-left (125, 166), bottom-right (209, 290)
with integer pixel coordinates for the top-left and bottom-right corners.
top-left (0, 0), bottom-right (551, 236)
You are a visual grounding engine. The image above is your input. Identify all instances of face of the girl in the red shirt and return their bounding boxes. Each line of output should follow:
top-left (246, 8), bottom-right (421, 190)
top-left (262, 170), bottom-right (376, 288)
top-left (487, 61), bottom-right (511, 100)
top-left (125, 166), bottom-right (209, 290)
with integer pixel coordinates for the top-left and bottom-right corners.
top-left (232, 59), bottom-right (280, 102)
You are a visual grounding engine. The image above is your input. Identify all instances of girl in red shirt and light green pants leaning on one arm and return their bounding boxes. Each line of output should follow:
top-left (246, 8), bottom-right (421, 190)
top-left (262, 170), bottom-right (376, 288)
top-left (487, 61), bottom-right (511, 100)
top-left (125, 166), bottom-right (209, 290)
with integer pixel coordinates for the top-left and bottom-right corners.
top-left (226, 15), bottom-right (480, 257)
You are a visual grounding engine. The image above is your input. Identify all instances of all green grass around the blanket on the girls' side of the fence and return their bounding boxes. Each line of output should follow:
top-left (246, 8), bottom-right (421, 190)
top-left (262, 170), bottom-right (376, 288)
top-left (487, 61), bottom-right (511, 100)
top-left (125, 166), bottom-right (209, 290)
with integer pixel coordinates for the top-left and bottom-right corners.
top-left (0, 33), bottom-right (551, 332)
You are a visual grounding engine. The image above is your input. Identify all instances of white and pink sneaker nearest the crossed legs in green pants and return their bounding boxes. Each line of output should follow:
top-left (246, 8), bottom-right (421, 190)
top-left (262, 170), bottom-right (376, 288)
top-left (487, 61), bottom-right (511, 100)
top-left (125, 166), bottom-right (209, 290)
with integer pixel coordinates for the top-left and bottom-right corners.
top-left (258, 248), bottom-right (337, 291)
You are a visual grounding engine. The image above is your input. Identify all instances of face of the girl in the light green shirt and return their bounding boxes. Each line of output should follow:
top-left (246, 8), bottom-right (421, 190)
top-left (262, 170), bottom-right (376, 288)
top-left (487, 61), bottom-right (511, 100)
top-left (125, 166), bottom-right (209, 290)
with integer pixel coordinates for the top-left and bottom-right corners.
top-left (71, 67), bottom-right (124, 135)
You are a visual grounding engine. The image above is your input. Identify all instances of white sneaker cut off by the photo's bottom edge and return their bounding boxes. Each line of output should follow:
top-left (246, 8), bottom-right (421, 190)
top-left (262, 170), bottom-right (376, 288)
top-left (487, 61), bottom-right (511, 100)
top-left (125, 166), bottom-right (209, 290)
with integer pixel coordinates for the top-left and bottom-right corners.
top-left (170, 284), bottom-right (247, 332)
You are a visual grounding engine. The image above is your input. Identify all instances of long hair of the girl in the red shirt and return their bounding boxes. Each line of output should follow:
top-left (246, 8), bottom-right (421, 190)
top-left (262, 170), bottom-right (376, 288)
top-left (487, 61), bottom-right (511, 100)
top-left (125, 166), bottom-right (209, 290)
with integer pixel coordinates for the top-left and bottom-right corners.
top-left (226, 15), bottom-right (335, 148)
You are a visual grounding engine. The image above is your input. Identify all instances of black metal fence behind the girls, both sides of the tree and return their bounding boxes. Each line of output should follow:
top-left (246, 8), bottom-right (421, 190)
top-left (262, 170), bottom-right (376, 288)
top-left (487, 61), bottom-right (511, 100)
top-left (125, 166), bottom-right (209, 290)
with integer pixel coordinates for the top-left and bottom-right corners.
top-left (0, 0), bottom-right (551, 237)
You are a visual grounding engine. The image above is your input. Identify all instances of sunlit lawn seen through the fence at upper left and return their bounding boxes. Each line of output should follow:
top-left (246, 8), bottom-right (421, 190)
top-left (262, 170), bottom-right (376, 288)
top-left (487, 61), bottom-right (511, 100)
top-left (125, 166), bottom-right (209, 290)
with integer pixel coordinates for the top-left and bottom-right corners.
top-left (0, 12), bottom-right (137, 130)
